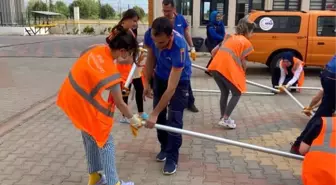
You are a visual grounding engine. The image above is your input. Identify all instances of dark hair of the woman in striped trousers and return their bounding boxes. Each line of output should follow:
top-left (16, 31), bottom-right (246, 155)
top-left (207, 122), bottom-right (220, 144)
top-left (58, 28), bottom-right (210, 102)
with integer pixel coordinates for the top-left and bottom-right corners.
top-left (108, 28), bottom-right (139, 61)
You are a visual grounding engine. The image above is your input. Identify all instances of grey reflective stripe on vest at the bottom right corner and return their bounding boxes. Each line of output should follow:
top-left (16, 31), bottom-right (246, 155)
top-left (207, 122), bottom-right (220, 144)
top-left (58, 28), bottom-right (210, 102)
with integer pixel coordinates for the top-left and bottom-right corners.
top-left (309, 117), bottom-right (336, 154)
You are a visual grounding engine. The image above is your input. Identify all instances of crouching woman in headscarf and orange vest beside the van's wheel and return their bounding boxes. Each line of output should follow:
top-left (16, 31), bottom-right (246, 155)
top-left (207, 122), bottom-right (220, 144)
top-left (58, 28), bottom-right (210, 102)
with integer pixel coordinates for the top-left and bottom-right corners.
top-left (272, 52), bottom-right (304, 92)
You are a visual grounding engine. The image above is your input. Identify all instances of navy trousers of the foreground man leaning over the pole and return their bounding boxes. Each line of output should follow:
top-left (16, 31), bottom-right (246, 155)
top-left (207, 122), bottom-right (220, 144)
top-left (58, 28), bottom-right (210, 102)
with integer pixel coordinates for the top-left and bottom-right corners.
top-left (153, 73), bottom-right (190, 164)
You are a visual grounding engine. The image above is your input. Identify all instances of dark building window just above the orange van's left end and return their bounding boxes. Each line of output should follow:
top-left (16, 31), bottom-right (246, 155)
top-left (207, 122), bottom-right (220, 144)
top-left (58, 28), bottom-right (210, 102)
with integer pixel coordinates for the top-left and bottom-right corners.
top-left (236, 0), bottom-right (265, 24)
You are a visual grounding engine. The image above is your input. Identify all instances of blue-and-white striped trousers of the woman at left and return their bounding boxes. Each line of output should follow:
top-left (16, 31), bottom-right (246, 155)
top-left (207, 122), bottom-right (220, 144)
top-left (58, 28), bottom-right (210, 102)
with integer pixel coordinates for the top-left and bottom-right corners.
top-left (82, 132), bottom-right (119, 185)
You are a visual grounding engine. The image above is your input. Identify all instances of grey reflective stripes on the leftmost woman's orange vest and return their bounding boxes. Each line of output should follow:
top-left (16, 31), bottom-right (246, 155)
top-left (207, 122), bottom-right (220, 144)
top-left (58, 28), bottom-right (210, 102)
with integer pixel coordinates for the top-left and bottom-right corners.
top-left (68, 73), bottom-right (120, 118)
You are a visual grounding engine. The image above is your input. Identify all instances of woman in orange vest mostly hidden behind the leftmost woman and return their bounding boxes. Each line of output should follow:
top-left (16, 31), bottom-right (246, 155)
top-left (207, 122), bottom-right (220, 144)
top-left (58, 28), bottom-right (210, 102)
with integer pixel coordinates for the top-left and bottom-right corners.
top-left (107, 9), bottom-right (148, 123)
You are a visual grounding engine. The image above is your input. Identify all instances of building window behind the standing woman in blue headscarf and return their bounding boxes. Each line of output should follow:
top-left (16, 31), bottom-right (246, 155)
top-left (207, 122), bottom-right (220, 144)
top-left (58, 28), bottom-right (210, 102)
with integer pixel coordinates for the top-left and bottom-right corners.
top-left (200, 0), bottom-right (229, 25)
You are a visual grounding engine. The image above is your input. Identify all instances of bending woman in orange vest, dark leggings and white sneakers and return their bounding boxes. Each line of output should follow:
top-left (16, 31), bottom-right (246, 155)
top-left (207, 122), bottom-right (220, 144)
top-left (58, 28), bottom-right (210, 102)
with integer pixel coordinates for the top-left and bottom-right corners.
top-left (208, 17), bottom-right (255, 129)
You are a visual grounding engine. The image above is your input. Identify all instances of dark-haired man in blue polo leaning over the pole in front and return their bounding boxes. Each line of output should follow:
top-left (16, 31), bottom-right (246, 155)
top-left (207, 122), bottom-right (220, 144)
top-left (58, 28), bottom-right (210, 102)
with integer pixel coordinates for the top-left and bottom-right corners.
top-left (144, 17), bottom-right (191, 174)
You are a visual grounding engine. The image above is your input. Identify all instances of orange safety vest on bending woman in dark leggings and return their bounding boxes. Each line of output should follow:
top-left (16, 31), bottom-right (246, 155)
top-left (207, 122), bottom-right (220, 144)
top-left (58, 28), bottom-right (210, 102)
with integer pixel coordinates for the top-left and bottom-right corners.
top-left (208, 34), bottom-right (254, 93)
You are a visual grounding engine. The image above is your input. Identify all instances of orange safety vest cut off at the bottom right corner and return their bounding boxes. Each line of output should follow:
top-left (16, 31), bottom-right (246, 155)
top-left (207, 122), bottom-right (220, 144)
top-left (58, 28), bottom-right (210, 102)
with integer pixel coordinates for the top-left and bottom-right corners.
top-left (302, 117), bottom-right (336, 185)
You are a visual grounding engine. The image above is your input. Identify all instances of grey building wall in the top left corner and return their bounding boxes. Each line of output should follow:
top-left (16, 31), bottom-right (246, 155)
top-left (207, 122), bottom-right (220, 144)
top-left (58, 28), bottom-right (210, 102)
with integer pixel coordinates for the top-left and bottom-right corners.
top-left (0, 0), bottom-right (25, 26)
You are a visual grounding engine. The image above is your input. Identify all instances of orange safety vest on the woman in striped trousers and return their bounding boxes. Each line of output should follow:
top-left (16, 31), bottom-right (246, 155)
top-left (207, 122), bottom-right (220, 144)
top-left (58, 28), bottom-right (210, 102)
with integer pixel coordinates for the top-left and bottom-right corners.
top-left (56, 45), bottom-right (121, 147)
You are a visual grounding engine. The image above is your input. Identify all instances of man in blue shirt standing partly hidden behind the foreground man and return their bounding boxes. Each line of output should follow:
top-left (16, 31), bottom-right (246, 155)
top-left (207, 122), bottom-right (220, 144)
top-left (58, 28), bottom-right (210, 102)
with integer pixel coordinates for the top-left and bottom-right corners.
top-left (162, 0), bottom-right (198, 112)
